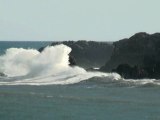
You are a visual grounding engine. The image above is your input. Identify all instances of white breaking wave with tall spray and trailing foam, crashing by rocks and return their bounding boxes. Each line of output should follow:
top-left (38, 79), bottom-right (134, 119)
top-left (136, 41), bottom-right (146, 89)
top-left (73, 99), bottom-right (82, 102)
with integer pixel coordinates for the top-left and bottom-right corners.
top-left (0, 44), bottom-right (120, 85)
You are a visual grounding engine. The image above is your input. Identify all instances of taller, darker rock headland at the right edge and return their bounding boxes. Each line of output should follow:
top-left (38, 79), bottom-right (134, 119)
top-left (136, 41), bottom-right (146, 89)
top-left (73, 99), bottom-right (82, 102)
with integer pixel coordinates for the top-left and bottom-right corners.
top-left (101, 33), bottom-right (160, 79)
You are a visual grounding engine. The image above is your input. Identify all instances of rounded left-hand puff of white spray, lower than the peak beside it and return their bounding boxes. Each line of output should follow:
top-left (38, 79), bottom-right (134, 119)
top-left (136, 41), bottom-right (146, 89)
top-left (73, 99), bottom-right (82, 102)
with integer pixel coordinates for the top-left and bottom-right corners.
top-left (0, 48), bottom-right (39, 77)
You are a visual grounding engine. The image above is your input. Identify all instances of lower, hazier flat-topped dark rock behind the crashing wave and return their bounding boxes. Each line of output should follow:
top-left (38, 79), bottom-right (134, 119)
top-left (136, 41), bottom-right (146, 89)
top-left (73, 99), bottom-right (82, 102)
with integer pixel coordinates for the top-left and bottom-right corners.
top-left (39, 40), bottom-right (113, 68)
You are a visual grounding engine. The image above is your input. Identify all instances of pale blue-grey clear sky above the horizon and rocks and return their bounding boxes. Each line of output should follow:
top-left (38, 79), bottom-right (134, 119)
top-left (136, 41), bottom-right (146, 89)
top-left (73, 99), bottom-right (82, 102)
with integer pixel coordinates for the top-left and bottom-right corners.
top-left (0, 0), bottom-right (160, 41)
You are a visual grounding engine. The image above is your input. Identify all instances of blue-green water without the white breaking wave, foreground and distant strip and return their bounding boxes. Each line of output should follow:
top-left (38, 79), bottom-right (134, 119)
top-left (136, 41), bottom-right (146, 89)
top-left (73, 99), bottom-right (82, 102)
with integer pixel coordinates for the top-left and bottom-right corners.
top-left (0, 42), bottom-right (160, 120)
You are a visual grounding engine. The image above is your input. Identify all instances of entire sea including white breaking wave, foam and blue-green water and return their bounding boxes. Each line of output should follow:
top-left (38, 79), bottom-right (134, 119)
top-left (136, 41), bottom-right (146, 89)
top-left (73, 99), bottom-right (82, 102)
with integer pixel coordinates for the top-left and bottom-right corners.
top-left (0, 41), bottom-right (160, 120)
